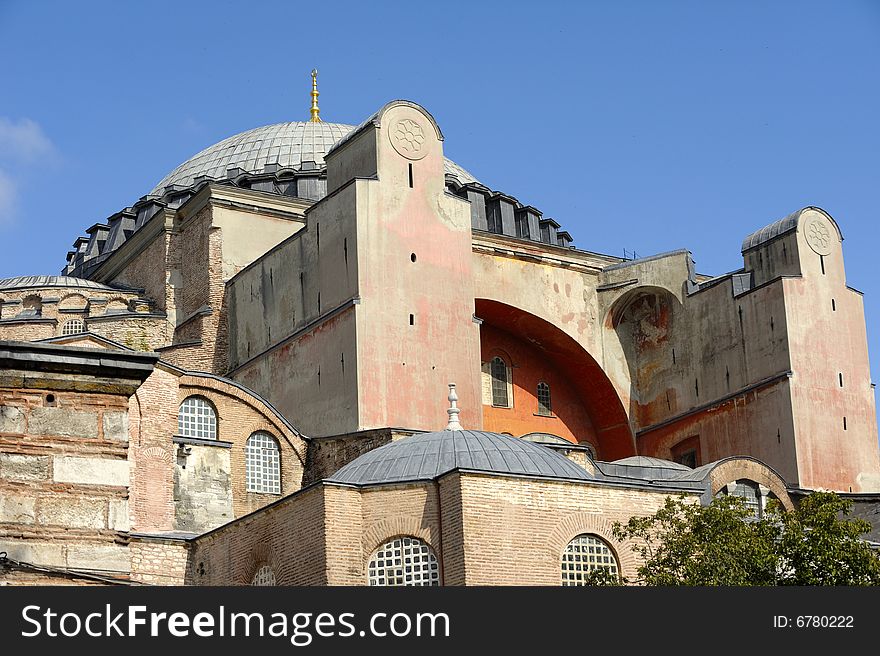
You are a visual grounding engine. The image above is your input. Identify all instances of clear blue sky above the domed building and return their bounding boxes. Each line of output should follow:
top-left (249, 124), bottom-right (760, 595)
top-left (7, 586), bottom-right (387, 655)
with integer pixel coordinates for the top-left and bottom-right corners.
top-left (0, 0), bottom-right (880, 410)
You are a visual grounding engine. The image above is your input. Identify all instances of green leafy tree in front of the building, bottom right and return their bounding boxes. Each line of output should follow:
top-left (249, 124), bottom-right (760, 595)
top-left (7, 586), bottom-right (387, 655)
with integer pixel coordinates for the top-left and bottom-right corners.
top-left (608, 492), bottom-right (880, 586)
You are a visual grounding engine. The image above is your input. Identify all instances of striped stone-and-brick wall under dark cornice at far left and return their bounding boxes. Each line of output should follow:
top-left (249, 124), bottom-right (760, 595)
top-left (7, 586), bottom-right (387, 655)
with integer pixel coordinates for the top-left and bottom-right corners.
top-left (0, 389), bottom-right (130, 574)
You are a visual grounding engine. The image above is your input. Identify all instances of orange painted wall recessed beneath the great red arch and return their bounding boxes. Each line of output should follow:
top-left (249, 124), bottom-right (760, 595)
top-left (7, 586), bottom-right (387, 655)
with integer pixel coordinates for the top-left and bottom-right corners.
top-left (480, 323), bottom-right (602, 458)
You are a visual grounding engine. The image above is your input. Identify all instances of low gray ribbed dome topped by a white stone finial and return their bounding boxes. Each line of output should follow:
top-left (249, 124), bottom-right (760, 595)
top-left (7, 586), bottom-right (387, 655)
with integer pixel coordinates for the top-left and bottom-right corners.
top-left (328, 430), bottom-right (593, 485)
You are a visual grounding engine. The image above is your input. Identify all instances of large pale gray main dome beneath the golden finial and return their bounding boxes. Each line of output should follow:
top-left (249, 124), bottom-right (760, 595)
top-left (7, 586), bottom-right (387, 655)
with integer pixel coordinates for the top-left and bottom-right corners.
top-left (150, 121), bottom-right (477, 196)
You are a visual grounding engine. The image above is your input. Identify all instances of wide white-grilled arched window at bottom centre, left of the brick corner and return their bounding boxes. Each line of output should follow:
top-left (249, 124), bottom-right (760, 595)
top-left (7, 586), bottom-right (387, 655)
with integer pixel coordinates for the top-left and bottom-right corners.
top-left (367, 536), bottom-right (440, 586)
